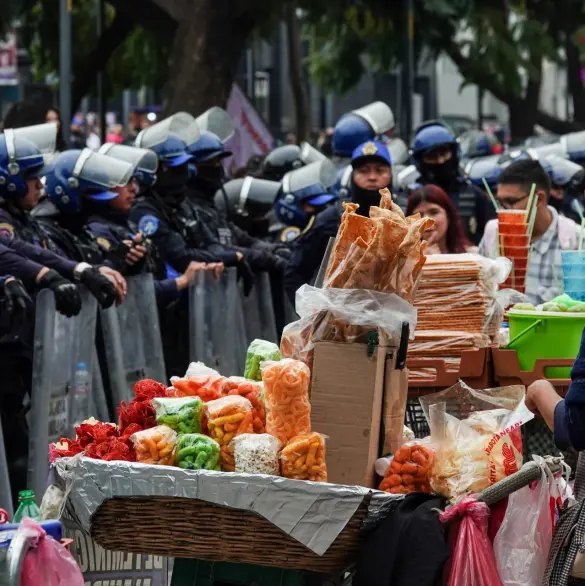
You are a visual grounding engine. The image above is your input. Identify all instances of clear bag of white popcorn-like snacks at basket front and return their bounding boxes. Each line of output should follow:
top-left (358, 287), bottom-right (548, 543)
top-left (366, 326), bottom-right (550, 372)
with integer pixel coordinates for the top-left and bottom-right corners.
top-left (232, 433), bottom-right (280, 476)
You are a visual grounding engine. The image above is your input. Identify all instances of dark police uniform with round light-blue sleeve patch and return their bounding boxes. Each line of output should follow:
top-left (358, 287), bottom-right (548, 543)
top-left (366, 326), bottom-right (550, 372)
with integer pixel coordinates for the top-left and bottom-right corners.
top-left (130, 190), bottom-right (238, 272)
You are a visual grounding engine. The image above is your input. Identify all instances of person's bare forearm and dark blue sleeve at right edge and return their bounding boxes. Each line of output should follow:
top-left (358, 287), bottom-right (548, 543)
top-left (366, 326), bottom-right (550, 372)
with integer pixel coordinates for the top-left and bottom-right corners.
top-left (526, 330), bottom-right (585, 451)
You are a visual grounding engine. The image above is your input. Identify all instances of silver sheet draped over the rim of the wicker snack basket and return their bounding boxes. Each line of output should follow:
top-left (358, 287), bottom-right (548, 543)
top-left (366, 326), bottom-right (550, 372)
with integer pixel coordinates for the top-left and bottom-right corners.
top-left (53, 456), bottom-right (396, 555)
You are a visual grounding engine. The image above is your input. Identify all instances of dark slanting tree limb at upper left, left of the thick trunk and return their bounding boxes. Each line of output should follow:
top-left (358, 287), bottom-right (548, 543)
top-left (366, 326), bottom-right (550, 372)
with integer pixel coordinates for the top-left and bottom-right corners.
top-left (71, 12), bottom-right (134, 112)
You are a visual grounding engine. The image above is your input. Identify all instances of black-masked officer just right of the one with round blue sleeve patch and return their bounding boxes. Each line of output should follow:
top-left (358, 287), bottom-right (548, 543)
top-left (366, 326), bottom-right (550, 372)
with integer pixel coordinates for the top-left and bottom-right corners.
top-left (187, 131), bottom-right (289, 271)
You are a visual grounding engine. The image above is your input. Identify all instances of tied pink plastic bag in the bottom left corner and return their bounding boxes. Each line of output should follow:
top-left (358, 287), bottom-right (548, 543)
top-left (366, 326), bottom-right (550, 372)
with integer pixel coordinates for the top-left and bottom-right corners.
top-left (17, 518), bottom-right (85, 586)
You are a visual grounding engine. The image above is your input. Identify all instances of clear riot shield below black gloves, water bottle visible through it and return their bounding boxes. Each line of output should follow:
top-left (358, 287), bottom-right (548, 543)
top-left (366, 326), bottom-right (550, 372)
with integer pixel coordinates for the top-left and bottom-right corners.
top-left (28, 288), bottom-right (97, 502)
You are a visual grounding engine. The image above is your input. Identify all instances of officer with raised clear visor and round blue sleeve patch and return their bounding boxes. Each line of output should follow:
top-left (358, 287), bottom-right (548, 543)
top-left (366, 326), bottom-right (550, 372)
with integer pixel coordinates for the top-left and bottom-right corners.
top-left (130, 112), bottom-right (245, 272)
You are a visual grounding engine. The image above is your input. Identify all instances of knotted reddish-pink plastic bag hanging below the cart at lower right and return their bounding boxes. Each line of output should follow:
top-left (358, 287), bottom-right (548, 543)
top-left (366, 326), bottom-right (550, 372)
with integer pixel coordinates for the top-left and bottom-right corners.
top-left (440, 497), bottom-right (502, 586)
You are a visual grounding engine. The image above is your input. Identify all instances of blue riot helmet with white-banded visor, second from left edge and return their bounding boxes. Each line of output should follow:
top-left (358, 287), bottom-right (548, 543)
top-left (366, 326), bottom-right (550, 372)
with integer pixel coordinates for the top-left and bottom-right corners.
top-left (45, 149), bottom-right (134, 214)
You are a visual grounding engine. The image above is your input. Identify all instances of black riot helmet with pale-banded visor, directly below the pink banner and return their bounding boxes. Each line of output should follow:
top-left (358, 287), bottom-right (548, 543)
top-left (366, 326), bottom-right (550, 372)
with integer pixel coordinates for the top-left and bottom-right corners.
top-left (215, 176), bottom-right (281, 218)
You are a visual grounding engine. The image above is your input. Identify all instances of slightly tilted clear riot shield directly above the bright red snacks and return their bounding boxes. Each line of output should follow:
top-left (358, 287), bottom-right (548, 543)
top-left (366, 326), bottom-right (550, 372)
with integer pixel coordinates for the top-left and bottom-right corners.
top-left (100, 274), bottom-right (167, 409)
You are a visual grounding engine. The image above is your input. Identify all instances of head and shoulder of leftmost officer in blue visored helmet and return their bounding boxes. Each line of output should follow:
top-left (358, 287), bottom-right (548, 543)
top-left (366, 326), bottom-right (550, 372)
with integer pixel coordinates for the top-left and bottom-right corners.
top-left (0, 124), bottom-right (62, 248)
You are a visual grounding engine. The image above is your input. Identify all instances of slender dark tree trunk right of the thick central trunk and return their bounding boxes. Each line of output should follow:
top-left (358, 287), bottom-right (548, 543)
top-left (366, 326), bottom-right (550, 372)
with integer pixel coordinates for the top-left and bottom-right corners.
top-left (284, 2), bottom-right (311, 143)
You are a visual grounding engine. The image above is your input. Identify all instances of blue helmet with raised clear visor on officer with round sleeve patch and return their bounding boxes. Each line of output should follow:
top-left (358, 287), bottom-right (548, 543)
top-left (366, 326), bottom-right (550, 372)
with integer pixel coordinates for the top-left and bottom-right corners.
top-left (134, 112), bottom-right (201, 167)
